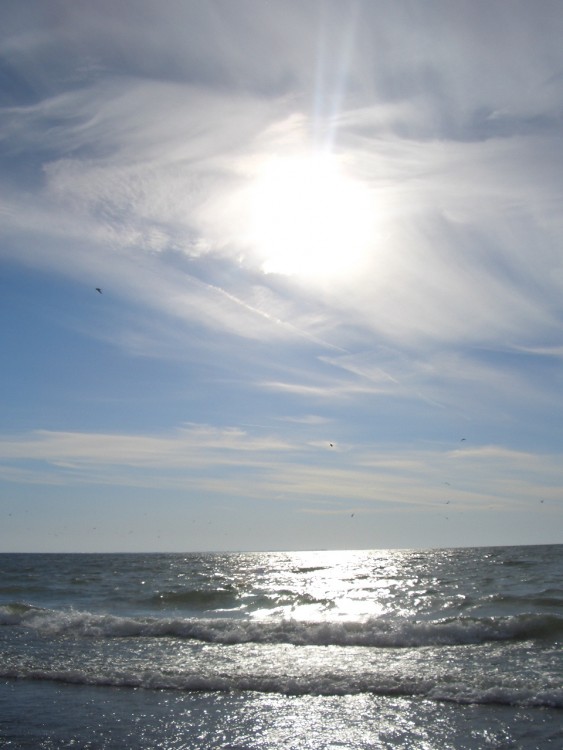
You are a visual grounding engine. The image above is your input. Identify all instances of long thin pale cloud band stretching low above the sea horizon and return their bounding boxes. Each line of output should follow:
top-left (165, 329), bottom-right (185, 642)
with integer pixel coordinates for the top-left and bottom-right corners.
top-left (0, 425), bottom-right (563, 509)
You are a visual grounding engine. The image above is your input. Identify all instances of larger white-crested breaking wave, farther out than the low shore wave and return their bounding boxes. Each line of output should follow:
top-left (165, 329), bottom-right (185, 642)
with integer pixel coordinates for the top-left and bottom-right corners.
top-left (0, 603), bottom-right (563, 648)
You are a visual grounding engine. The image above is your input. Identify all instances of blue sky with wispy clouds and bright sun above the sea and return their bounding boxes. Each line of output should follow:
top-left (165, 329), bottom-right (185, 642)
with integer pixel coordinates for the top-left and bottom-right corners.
top-left (0, 0), bottom-right (563, 552)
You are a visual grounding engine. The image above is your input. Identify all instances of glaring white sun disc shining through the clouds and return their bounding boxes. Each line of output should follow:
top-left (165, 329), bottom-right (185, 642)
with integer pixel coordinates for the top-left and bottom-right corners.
top-left (248, 155), bottom-right (374, 281)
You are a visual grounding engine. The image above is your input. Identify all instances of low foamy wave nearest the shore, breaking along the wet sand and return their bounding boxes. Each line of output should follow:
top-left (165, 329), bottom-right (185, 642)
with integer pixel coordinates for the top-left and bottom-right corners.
top-left (0, 666), bottom-right (563, 708)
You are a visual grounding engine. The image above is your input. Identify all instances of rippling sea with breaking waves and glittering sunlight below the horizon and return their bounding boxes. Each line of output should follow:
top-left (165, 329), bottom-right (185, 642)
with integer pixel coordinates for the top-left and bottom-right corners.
top-left (0, 545), bottom-right (563, 750)
